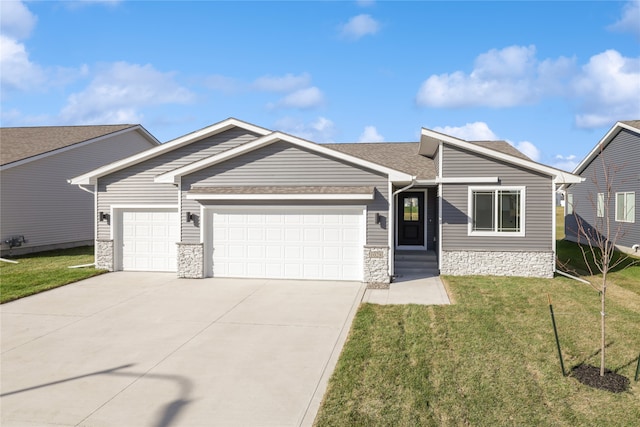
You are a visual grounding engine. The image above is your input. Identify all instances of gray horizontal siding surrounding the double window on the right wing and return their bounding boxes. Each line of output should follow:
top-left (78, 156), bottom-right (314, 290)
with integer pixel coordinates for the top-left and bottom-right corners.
top-left (442, 145), bottom-right (554, 251)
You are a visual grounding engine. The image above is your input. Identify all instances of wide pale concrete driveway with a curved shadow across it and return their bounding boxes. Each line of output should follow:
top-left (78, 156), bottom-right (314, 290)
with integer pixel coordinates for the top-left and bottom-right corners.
top-left (0, 272), bottom-right (364, 427)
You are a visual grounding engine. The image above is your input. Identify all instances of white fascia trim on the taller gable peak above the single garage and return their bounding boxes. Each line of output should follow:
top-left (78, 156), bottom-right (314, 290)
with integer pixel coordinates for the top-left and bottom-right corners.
top-left (68, 118), bottom-right (271, 184)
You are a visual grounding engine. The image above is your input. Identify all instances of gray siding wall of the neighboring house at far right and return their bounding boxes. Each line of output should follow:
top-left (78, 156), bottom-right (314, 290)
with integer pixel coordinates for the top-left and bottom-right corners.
top-left (565, 129), bottom-right (640, 248)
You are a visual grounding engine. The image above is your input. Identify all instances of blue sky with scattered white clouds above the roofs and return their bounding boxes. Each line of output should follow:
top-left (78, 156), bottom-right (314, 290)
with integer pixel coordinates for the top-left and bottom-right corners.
top-left (0, 0), bottom-right (640, 170)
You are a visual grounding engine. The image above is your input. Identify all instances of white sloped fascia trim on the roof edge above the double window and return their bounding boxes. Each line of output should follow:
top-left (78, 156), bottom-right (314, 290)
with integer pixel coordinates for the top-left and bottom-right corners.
top-left (422, 128), bottom-right (583, 184)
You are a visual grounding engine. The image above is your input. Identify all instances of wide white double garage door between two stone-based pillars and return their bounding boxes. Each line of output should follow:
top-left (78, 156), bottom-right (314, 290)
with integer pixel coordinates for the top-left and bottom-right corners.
top-left (212, 207), bottom-right (364, 280)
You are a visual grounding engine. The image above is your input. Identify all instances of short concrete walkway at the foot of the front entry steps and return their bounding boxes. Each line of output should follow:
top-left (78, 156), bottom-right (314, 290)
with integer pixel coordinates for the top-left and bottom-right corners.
top-left (362, 276), bottom-right (451, 305)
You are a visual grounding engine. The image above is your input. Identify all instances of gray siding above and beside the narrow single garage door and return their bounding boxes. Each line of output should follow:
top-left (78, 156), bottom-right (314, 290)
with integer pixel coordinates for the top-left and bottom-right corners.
top-left (98, 128), bottom-right (258, 239)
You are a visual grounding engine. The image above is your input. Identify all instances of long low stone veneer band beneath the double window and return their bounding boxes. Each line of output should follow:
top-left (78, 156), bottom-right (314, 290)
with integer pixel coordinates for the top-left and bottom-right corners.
top-left (440, 251), bottom-right (555, 279)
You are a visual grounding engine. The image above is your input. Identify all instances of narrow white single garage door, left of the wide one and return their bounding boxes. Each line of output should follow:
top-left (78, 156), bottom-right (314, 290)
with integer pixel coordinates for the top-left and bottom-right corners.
top-left (121, 209), bottom-right (180, 271)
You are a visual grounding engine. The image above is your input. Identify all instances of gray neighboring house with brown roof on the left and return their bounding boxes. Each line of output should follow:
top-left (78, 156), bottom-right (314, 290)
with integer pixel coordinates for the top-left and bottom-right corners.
top-left (0, 125), bottom-right (159, 255)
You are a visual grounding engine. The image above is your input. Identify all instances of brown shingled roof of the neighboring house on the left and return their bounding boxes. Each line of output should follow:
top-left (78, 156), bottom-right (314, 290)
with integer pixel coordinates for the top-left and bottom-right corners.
top-left (0, 124), bottom-right (153, 166)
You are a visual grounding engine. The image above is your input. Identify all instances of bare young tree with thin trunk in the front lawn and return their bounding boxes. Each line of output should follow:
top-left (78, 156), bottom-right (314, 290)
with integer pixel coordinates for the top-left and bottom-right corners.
top-left (574, 149), bottom-right (629, 376)
